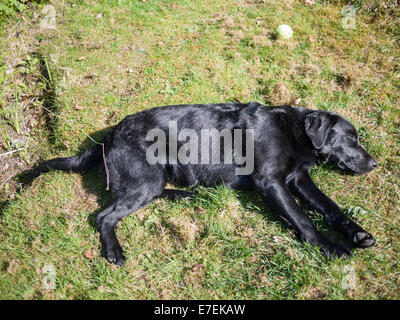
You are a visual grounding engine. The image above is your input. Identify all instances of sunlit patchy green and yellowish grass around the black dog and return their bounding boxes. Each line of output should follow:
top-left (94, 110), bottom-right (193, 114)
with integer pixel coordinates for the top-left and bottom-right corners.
top-left (0, 0), bottom-right (400, 299)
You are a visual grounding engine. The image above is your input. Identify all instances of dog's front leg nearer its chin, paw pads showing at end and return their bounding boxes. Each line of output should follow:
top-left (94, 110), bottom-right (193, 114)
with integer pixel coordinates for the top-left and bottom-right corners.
top-left (291, 171), bottom-right (375, 248)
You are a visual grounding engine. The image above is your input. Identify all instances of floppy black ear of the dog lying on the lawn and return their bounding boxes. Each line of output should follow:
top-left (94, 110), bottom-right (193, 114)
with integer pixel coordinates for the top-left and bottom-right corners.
top-left (304, 111), bottom-right (336, 149)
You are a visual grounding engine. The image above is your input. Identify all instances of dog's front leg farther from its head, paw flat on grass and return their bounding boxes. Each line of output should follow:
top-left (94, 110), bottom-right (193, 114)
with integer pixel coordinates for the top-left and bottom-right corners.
top-left (255, 180), bottom-right (351, 258)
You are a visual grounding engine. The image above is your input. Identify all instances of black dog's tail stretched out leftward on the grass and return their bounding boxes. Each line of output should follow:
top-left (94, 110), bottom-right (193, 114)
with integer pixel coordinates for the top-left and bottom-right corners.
top-left (34, 145), bottom-right (102, 174)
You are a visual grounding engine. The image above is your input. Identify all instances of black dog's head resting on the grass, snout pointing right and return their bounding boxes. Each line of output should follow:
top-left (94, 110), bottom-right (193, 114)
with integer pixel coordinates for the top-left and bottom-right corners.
top-left (304, 111), bottom-right (378, 174)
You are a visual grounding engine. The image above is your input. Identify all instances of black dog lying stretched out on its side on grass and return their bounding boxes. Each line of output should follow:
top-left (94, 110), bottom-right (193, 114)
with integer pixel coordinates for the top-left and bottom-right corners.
top-left (35, 102), bottom-right (377, 265)
